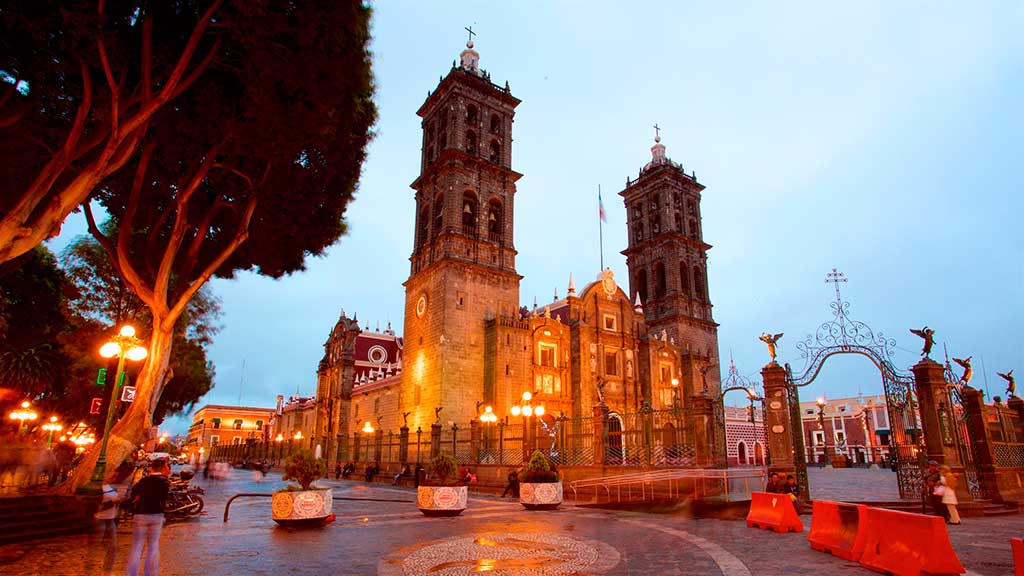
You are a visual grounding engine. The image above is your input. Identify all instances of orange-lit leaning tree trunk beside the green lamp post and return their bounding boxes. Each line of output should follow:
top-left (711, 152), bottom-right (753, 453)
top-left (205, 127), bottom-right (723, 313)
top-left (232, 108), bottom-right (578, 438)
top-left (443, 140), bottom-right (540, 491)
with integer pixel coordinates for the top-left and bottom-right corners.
top-left (66, 318), bottom-right (174, 493)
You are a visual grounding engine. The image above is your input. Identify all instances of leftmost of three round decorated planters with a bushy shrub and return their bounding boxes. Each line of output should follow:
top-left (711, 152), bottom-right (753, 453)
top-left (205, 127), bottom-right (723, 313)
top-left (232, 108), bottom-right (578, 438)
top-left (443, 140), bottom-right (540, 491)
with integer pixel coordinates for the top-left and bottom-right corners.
top-left (271, 450), bottom-right (334, 526)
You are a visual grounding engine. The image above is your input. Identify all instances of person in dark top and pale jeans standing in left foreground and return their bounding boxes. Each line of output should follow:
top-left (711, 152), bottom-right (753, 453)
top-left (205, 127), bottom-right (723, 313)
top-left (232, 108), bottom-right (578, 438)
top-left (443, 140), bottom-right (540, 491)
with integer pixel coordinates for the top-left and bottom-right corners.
top-left (128, 459), bottom-right (171, 576)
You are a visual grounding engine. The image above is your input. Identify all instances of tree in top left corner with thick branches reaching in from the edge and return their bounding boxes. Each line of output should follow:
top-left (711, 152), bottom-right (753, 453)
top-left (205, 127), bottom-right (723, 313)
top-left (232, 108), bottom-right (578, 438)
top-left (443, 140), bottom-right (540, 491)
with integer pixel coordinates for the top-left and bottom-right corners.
top-left (0, 0), bottom-right (223, 263)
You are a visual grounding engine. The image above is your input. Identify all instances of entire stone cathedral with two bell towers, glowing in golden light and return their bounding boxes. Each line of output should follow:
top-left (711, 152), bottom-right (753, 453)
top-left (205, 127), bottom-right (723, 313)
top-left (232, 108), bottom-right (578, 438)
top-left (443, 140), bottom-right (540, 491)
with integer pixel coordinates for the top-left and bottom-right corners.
top-left (311, 41), bottom-right (721, 461)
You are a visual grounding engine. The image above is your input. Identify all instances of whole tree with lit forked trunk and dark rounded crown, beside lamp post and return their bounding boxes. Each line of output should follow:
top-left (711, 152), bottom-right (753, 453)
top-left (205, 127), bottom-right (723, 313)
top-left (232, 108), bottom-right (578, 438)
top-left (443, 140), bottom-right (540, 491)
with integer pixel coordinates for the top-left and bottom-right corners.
top-left (65, 0), bottom-right (376, 487)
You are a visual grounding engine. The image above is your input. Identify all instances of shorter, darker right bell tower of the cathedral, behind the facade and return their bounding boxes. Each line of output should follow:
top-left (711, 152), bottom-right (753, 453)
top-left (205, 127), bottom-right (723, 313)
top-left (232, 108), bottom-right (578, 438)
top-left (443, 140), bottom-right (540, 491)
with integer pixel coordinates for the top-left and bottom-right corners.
top-left (620, 132), bottom-right (721, 394)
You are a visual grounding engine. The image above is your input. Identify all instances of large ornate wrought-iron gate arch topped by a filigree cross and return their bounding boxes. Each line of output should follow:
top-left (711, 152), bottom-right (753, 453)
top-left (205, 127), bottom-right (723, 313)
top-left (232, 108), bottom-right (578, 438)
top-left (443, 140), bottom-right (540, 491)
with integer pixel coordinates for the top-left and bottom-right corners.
top-left (785, 269), bottom-right (926, 498)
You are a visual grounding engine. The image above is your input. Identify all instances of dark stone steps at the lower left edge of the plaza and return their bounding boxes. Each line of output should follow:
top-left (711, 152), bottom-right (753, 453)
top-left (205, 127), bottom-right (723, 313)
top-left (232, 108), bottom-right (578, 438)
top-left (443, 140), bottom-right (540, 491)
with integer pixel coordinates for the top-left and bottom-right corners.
top-left (0, 496), bottom-right (90, 545)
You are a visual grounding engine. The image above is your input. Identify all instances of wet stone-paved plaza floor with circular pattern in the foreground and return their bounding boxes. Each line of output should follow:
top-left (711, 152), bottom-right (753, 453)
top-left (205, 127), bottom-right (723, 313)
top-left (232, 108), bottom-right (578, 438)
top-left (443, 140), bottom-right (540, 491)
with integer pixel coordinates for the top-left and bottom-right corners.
top-left (0, 470), bottom-right (1024, 576)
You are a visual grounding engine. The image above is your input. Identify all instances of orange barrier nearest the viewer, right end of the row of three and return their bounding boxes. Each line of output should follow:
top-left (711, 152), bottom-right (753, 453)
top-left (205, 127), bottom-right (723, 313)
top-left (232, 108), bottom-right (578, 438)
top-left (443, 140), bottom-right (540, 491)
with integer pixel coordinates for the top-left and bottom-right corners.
top-left (860, 507), bottom-right (965, 576)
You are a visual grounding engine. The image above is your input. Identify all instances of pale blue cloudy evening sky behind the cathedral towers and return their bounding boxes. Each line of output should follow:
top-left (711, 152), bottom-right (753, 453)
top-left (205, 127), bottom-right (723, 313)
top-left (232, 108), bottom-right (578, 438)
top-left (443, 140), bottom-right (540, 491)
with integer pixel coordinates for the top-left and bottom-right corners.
top-left (50, 0), bottom-right (1024, 433)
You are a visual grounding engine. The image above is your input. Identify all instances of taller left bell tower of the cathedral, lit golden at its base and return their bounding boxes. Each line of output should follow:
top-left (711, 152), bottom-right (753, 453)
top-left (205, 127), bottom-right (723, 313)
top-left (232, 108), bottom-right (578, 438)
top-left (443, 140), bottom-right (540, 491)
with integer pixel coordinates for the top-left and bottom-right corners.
top-left (400, 33), bottom-right (522, 429)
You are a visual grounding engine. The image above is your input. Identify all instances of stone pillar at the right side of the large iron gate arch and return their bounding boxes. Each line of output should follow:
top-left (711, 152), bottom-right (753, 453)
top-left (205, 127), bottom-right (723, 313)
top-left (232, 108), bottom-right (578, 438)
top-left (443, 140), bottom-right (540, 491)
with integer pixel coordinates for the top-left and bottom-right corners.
top-left (910, 358), bottom-right (964, 468)
